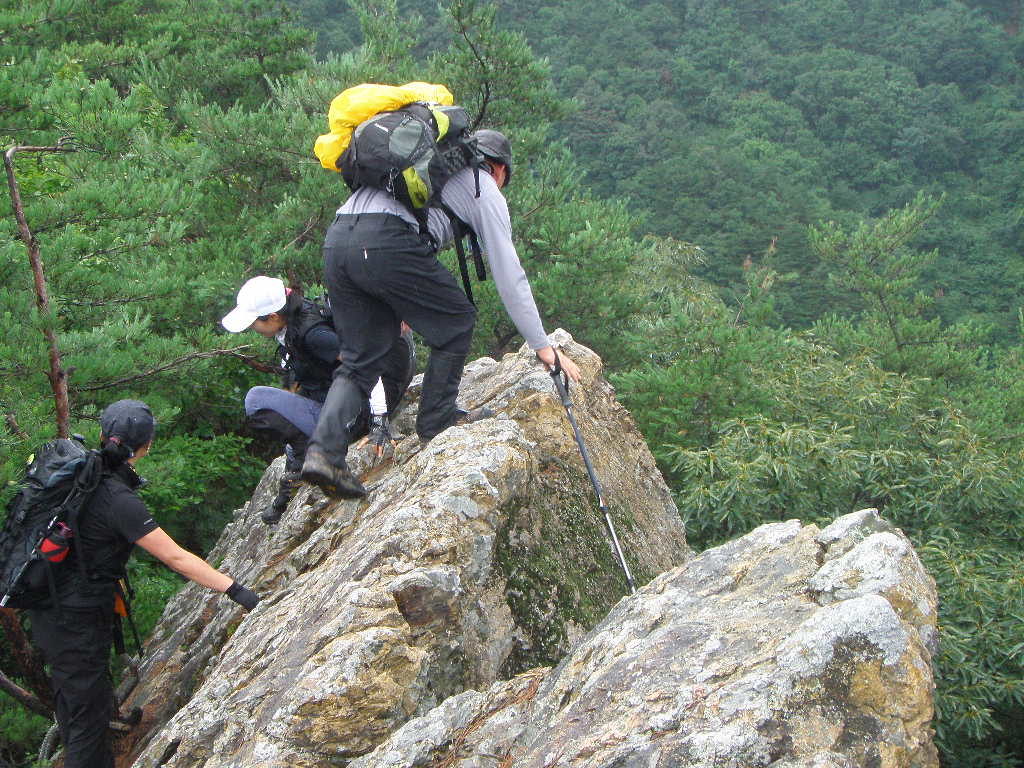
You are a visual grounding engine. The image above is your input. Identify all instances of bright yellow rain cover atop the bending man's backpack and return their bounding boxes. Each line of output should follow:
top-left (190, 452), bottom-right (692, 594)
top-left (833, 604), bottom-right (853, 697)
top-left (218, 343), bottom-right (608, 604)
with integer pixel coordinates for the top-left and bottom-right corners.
top-left (313, 83), bottom-right (455, 173)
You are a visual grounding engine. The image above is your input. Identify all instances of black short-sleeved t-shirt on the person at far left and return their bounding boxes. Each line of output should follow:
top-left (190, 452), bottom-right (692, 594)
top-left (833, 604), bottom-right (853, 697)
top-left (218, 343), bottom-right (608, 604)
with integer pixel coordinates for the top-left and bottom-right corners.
top-left (56, 464), bottom-right (160, 608)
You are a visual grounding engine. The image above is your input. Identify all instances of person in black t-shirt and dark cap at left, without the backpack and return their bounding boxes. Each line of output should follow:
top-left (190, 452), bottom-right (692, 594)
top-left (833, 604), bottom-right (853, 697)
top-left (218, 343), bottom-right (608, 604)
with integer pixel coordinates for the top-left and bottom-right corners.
top-left (30, 400), bottom-right (259, 768)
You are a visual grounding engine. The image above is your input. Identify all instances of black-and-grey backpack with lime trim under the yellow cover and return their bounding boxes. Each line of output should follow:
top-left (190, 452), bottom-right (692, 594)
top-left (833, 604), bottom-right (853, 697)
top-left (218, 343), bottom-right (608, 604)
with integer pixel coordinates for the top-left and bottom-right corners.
top-left (337, 101), bottom-right (486, 301)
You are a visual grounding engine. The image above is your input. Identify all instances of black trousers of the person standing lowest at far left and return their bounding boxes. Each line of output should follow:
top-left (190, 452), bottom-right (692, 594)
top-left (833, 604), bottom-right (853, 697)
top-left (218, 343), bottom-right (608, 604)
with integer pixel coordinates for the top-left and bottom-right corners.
top-left (30, 603), bottom-right (114, 768)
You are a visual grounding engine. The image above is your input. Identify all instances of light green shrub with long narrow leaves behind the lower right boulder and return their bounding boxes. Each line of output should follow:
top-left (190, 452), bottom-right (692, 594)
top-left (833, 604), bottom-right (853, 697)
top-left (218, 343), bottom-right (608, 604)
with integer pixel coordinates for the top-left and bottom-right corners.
top-left (671, 360), bottom-right (1024, 765)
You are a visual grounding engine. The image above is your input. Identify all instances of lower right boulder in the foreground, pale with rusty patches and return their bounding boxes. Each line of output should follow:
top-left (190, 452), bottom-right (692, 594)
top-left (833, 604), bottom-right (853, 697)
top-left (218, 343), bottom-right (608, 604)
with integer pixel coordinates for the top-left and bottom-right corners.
top-left (350, 510), bottom-right (939, 768)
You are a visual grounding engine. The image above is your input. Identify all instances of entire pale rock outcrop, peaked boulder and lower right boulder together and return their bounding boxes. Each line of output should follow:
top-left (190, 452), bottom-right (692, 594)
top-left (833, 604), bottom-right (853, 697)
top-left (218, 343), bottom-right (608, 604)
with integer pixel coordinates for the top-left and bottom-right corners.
top-left (116, 334), bottom-right (938, 768)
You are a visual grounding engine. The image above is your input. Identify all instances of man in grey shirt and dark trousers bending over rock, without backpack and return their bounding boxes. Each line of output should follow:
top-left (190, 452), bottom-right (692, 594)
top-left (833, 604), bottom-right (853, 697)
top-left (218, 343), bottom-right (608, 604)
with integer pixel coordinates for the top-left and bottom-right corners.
top-left (302, 83), bottom-right (580, 498)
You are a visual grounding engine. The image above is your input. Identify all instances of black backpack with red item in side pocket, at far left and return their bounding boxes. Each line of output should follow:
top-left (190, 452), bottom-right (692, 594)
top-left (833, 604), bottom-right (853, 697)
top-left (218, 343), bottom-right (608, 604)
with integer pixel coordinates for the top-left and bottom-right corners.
top-left (0, 435), bottom-right (103, 608)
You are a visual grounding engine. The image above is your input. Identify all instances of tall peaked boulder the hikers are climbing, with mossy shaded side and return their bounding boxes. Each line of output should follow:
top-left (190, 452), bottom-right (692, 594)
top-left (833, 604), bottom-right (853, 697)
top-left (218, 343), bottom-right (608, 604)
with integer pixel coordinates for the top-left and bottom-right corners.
top-left (123, 332), bottom-right (691, 768)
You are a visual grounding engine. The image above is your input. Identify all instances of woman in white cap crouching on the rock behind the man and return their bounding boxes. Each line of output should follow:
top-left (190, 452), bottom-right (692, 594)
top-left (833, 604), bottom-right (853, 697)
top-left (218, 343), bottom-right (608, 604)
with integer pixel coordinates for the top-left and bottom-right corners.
top-left (221, 275), bottom-right (416, 525)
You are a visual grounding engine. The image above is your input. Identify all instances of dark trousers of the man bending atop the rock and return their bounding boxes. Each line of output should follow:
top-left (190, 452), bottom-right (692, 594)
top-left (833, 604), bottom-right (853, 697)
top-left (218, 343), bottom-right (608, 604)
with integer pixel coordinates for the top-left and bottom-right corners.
top-left (309, 213), bottom-right (476, 466)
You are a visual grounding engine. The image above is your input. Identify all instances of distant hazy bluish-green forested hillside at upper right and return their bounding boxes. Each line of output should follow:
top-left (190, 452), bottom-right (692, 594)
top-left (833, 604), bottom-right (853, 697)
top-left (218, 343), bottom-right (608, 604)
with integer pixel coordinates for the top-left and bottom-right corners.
top-left (295, 0), bottom-right (1024, 335)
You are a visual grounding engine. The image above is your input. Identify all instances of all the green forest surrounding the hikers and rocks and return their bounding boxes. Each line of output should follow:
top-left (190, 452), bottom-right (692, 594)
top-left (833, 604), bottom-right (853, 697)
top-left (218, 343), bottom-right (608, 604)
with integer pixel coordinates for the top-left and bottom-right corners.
top-left (0, 0), bottom-right (1024, 767)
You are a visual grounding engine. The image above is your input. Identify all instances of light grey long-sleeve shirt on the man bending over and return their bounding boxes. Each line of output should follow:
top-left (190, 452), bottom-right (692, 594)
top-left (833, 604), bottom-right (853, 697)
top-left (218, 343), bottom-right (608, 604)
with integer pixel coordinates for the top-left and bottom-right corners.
top-left (338, 168), bottom-right (550, 349)
